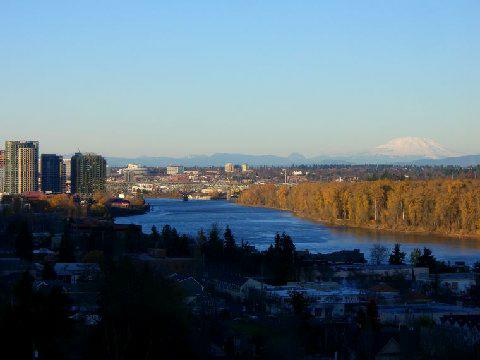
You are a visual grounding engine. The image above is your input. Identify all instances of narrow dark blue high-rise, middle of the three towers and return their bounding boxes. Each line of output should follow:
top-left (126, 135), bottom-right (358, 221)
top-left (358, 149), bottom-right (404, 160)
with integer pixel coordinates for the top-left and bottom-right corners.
top-left (40, 154), bottom-right (65, 194)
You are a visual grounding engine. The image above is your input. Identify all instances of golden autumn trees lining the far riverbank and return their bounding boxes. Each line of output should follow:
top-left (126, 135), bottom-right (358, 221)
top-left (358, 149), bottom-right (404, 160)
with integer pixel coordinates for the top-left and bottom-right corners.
top-left (238, 180), bottom-right (480, 237)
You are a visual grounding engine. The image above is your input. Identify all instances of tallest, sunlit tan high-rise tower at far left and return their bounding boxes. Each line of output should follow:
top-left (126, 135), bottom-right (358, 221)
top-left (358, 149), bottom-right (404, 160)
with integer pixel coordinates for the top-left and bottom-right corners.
top-left (4, 141), bottom-right (39, 194)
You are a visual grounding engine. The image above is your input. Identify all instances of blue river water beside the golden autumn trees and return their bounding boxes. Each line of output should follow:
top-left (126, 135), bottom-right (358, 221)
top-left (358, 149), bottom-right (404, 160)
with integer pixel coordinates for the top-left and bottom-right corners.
top-left (116, 199), bottom-right (480, 264)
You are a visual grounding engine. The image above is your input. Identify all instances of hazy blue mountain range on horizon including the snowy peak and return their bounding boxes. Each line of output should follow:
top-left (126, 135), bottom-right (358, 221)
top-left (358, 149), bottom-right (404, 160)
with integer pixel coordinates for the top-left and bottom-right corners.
top-left (107, 137), bottom-right (480, 167)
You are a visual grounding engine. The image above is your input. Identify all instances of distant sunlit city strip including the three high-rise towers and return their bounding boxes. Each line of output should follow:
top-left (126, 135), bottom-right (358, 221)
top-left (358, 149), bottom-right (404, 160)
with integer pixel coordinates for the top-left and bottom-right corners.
top-left (0, 141), bottom-right (478, 199)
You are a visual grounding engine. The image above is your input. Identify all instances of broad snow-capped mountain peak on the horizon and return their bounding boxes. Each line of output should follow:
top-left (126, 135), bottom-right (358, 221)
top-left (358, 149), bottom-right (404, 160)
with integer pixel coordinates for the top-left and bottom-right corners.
top-left (372, 137), bottom-right (460, 159)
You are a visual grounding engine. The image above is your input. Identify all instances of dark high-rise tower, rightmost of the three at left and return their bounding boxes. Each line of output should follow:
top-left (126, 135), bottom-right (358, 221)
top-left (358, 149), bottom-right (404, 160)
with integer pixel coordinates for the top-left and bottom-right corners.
top-left (71, 153), bottom-right (107, 195)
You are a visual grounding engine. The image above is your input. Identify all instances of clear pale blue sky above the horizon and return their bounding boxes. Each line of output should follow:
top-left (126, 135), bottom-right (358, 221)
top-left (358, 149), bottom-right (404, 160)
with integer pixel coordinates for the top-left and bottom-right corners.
top-left (0, 0), bottom-right (480, 156)
